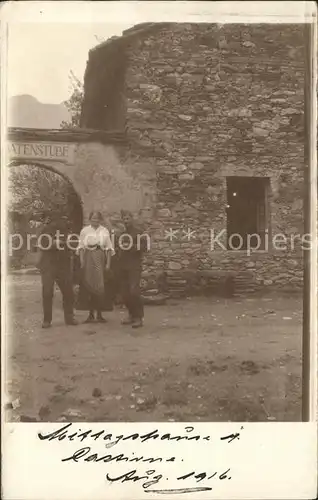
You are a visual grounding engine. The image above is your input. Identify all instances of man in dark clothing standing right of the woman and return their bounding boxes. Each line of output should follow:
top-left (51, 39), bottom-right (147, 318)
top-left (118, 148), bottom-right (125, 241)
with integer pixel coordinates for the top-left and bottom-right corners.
top-left (118, 210), bottom-right (147, 328)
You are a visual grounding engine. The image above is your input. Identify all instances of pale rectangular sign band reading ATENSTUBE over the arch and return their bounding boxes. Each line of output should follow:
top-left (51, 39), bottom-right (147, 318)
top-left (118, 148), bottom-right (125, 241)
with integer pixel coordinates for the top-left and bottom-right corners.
top-left (7, 141), bottom-right (76, 165)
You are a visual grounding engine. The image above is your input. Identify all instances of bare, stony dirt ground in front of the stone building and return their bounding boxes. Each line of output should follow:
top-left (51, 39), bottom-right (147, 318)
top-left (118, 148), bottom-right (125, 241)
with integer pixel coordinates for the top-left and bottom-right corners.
top-left (3, 276), bottom-right (302, 422)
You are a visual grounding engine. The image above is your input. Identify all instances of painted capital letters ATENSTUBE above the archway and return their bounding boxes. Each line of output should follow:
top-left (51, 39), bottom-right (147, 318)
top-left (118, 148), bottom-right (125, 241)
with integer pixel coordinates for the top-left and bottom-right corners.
top-left (8, 142), bottom-right (69, 160)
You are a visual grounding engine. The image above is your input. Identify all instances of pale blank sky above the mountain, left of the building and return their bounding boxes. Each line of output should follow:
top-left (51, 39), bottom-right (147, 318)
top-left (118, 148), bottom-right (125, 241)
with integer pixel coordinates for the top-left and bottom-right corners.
top-left (7, 23), bottom-right (131, 104)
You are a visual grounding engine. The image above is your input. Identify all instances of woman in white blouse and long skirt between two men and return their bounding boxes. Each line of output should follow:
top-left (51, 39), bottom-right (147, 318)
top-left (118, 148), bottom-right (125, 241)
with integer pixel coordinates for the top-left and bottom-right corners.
top-left (76, 212), bottom-right (115, 323)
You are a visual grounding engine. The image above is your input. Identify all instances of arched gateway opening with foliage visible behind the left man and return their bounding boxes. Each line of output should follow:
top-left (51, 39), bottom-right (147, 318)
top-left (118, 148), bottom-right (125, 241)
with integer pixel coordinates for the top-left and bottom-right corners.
top-left (8, 160), bottom-right (83, 268)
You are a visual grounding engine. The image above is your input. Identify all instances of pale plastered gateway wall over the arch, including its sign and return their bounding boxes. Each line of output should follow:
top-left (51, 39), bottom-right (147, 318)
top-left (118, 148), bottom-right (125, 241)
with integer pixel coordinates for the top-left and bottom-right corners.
top-left (6, 128), bottom-right (129, 222)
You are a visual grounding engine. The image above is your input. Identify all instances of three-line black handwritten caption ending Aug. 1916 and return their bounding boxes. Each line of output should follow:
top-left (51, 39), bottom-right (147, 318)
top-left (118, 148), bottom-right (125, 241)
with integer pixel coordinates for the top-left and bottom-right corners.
top-left (38, 423), bottom-right (243, 495)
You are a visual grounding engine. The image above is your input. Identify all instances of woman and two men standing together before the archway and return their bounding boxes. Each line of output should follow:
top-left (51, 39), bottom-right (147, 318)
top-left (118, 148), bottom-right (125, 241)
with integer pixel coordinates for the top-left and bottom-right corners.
top-left (38, 211), bottom-right (146, 328)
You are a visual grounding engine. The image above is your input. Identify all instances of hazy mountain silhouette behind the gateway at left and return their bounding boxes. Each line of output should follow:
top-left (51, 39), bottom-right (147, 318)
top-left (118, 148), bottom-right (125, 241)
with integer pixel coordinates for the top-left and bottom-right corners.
top-left (8, 95), bottom-right (70, 129)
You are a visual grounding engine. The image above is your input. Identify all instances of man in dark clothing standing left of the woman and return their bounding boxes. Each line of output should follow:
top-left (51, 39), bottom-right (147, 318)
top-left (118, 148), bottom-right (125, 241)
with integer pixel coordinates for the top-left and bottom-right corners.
top-left (38, 214), bottom-right (77, 328)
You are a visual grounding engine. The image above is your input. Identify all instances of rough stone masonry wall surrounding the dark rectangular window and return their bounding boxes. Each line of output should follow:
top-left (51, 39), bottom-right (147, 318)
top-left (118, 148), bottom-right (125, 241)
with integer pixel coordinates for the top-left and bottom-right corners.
top-left (125, 24), bottom-right (304, 288)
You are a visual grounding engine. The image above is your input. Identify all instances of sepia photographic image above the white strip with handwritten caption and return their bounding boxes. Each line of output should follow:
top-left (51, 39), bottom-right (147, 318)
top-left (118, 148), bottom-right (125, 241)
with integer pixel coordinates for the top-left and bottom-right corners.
top-left (4, 20), bottom-right (311, 422)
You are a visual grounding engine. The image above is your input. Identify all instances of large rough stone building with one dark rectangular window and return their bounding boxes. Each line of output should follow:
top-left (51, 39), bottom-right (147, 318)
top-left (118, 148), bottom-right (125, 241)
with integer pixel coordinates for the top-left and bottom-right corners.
top-left (81, 23), bottom-right (304, 291)
